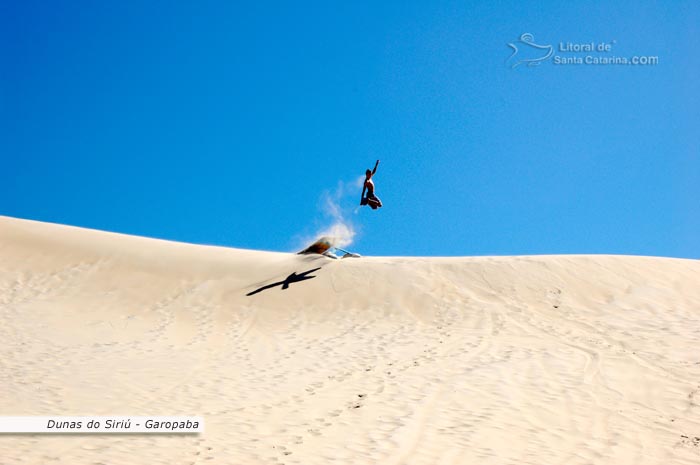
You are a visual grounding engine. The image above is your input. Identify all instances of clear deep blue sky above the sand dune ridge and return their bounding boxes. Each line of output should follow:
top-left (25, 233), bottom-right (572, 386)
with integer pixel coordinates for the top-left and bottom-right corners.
top-left (0, 0), bottom-right (700, 258)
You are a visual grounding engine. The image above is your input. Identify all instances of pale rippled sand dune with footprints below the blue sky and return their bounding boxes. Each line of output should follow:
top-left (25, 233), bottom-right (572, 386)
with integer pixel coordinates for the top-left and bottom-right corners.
top-left (0, 217), bottom-right (700, 465)
